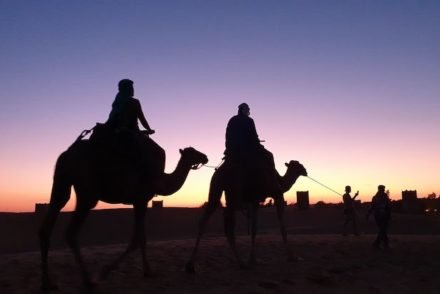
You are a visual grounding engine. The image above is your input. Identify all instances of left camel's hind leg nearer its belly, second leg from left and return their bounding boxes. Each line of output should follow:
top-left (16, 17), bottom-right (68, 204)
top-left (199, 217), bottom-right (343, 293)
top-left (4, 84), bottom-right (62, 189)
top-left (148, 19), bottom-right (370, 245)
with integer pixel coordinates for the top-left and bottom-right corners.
top-left (66, 198), bottom-right (97, 288)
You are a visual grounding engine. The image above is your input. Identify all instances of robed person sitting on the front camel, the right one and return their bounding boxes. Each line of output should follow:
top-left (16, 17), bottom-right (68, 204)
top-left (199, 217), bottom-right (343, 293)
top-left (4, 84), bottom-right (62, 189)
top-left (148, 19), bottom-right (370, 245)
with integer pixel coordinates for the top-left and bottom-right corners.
top-left (224, 103), bottom-right (282, 201)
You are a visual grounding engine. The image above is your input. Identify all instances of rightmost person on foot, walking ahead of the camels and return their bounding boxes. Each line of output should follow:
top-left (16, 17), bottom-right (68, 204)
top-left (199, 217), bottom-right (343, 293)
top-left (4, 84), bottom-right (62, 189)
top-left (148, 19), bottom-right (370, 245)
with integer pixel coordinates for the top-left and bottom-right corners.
top-left (367, 185), bottom-right (391, 249)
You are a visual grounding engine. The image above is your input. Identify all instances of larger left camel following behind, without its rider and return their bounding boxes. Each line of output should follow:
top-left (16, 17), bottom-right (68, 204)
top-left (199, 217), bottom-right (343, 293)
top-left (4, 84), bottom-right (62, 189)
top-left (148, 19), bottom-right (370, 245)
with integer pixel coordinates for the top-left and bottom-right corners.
top-left (39, 135), bottom-right (208, 290)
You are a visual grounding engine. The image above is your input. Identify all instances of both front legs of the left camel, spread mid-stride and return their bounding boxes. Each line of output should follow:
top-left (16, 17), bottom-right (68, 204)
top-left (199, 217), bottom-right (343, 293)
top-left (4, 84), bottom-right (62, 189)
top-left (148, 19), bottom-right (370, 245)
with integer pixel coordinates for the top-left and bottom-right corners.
top-left (100, 201), bottom-right (151, 279)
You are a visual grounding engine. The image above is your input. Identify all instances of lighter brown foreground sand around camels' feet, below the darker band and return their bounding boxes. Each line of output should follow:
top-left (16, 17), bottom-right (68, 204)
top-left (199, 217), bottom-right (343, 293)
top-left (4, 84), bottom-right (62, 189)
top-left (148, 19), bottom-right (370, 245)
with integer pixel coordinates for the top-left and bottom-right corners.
top-left (0, 234), bottom-right (440, 294)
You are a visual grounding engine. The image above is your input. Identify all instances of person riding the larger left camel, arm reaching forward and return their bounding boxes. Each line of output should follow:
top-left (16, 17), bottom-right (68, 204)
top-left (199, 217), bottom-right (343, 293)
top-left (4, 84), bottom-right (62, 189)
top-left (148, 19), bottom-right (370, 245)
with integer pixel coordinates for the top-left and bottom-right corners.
top-left (105, 79), bottom-right (165, 176)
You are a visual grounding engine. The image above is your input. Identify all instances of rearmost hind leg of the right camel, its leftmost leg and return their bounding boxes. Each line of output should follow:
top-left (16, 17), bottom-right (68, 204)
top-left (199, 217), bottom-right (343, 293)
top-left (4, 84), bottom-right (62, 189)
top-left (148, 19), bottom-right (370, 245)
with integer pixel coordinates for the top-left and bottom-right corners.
top-left (185, 170), bottom-right (223, 273)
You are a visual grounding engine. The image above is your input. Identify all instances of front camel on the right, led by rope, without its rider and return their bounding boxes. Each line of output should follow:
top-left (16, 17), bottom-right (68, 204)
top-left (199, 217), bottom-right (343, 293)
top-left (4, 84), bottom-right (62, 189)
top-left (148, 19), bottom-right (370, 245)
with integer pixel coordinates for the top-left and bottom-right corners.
top-left (185, 160), bottom-right (307, 273)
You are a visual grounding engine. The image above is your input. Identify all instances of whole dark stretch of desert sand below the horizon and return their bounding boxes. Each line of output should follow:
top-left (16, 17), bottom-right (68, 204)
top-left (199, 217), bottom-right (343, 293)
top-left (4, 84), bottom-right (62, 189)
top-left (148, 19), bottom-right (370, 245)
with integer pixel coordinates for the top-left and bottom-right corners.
top-left (0, 208), bottom-right (440, 294)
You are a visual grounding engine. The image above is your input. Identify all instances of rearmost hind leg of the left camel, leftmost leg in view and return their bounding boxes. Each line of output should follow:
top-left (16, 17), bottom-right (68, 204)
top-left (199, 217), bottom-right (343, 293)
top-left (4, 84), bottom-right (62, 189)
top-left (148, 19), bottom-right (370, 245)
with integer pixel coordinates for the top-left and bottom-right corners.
top-left (38, 180), bottom-right (70, 291)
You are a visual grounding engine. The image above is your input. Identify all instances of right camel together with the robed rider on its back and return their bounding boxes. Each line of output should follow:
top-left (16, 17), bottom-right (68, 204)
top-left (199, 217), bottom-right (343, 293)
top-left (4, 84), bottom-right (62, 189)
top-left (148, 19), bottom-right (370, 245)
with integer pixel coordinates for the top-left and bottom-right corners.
top-left (186, 103), bottom-right (307, 272)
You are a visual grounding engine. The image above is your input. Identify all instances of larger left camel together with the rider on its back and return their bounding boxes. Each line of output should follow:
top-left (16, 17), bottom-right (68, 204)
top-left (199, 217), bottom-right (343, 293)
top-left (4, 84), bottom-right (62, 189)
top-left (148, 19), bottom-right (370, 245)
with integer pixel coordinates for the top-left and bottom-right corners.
top-left (39, 80), bottom-right (208, 290)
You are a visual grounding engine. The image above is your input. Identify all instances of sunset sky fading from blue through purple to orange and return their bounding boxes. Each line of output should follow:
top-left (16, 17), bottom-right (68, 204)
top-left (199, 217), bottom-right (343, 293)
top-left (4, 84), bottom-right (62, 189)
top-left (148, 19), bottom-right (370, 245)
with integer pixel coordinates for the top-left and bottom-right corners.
top-left (0, 0), bottom-right (440, 211)
